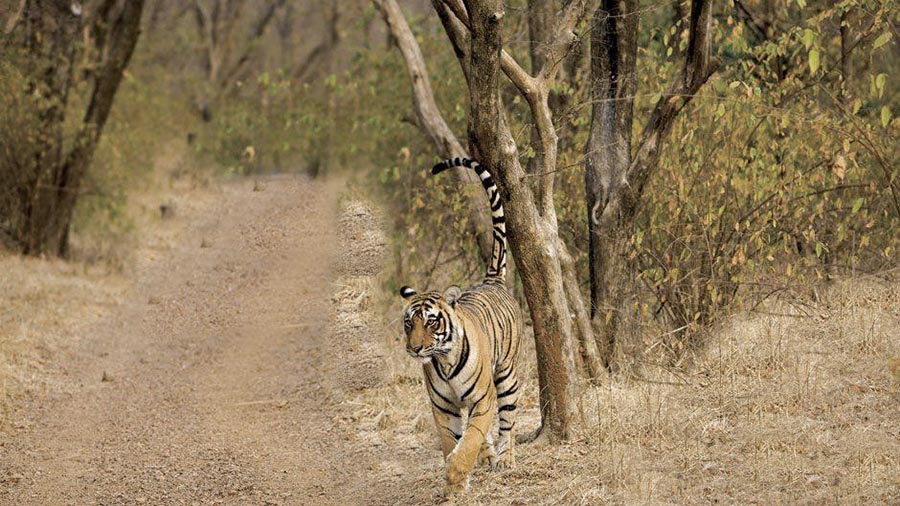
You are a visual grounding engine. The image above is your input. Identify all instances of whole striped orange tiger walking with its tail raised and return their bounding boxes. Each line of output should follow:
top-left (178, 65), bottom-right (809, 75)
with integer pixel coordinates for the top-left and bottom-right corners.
top-left (400, 158), bottom-right (523, 495)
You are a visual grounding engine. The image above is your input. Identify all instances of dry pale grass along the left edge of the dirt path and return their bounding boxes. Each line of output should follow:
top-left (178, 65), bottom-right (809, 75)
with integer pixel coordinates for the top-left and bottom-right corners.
top-left (0, 140), bottom-right (217, 427)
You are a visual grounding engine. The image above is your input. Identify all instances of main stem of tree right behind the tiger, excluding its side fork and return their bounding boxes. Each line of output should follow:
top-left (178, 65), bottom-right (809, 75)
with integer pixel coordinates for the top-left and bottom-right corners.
top-left (466, 0), bottom-right (576, 440)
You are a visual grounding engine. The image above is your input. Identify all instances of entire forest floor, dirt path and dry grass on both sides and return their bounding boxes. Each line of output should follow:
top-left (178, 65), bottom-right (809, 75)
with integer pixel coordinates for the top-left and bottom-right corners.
top-left (0, 172), bottom-right (900, 506)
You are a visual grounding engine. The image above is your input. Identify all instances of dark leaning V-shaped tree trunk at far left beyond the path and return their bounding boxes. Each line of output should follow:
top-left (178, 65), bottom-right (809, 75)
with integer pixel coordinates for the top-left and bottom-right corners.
top-left (11, 0), bottom-right (144, 256)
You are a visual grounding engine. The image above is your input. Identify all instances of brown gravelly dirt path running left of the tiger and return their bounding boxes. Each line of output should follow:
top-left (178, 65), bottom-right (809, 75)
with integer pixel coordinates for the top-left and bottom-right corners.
top-left (0, 177), bottom-right (431, 505)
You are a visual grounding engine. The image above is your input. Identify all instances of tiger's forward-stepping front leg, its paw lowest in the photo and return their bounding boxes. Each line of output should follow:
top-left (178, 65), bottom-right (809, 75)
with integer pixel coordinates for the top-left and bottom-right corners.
top-left (446, 384), bottom-right (497, 495)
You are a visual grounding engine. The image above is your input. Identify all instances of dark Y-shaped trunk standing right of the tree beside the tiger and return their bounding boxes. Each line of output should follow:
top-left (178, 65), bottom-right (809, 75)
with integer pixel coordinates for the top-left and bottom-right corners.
top-left (585, 0), bottom-right (715, 365)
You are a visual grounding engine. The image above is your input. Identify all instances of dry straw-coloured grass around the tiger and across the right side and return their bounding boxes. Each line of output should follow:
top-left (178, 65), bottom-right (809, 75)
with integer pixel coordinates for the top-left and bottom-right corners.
top-left (348, 209), bottom-right (900, 505)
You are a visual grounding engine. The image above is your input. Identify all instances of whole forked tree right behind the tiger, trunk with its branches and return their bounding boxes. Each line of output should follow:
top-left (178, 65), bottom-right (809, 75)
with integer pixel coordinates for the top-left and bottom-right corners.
top-left (445, 1), bottom-right (588, 440)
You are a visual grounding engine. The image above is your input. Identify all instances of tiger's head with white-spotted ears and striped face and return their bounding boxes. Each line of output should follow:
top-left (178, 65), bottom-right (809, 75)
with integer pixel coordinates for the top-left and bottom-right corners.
top-left (400, 285), bottom-right (462, 364)
